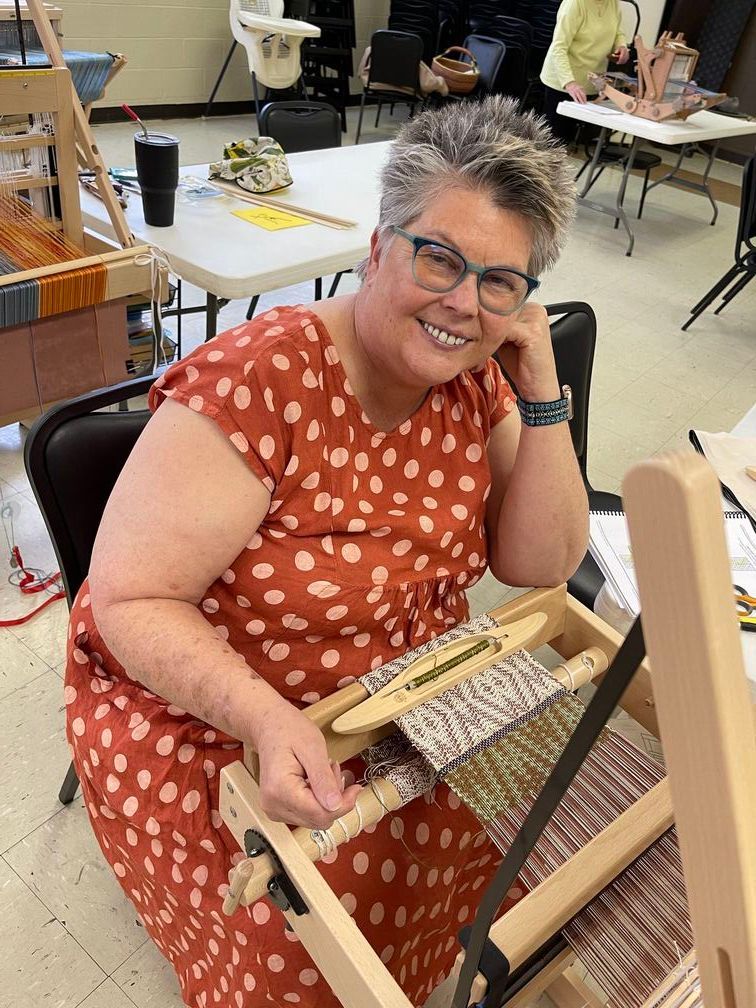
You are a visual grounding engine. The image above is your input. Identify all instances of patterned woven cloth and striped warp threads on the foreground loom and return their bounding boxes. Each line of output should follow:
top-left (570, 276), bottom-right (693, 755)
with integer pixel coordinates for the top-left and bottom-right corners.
top-left (361, 616), bottom-right (696, 1008)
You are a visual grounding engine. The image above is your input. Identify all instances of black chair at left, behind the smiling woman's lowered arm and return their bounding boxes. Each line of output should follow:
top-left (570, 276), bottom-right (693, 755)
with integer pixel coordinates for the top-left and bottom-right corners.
top-left (23, 375), bottom-right (155, 804)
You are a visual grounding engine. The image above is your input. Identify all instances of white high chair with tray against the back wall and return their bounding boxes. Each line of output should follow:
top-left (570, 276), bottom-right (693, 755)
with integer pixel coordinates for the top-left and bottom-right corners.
top-left (229, 0), bottom-right (321, 97)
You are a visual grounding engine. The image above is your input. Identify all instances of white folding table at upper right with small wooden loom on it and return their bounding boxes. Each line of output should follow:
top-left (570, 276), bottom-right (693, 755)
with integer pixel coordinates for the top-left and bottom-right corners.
top-left (556, 101), bottom-right (756, 255)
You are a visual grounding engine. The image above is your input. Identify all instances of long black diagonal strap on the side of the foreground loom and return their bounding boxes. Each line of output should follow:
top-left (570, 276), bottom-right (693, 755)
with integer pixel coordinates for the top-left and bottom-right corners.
top-left (452, 617), bottom-right (646, 1008)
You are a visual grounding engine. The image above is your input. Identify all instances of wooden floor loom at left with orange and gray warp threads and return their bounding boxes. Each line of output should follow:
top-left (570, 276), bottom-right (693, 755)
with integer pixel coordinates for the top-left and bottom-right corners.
top-left (0, 0), bottom-right (160, 425)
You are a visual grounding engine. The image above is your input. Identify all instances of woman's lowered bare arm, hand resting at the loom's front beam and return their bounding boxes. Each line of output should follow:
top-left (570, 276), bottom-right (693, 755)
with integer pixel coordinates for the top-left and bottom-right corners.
top-left (90, 399), bottom-right (359, 828)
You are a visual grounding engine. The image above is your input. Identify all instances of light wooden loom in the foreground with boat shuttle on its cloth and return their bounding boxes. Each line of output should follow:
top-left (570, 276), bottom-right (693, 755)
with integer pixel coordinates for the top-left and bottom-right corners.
top-left (221, 455), bottom-right (756, 1008)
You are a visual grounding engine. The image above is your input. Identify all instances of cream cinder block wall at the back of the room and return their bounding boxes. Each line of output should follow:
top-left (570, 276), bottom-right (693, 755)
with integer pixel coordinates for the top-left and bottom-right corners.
top-left (57, 0), bottom-right (389, 107)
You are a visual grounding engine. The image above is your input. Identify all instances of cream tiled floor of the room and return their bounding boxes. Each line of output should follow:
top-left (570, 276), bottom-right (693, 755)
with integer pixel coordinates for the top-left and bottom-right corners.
top-left (0, 104), bottom-right (756, 1008)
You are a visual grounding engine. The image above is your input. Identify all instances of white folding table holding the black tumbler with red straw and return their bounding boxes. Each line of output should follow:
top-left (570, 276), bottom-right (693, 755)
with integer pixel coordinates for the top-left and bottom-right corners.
top-left (82, 142), bottom-right (389, 339)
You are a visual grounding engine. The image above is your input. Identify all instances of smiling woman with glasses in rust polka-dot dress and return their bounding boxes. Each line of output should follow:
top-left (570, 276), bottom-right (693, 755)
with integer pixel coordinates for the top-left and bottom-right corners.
top-left (66, 99), bottom-right (587, 1008)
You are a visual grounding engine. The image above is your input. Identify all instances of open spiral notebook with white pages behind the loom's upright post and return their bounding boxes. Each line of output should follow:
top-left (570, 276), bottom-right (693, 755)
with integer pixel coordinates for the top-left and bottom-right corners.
top-left (588, 511), bottom-right (756, 616)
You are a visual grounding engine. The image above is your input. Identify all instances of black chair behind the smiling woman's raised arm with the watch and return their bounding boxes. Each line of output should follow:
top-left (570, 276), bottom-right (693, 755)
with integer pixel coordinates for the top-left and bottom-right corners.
top-left (497, 301), bottom-right (622, 609)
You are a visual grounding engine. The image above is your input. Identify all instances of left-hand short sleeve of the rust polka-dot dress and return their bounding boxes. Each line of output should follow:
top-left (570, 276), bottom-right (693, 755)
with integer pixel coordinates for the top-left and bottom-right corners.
top-left (149, 316), bottom-right (291, 493)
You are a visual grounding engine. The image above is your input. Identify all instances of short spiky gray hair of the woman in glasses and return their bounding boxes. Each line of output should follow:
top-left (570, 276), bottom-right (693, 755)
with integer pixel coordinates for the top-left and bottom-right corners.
top-left (356, 95), bottom-right (575, 279)
